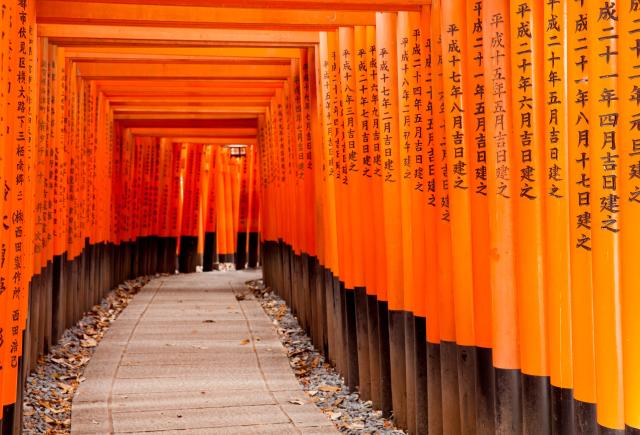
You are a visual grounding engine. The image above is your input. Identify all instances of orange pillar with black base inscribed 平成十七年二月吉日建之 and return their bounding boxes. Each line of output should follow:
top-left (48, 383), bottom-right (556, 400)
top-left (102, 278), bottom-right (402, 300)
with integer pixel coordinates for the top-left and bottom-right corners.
top-left (376, 12), bottom-right (407, 427)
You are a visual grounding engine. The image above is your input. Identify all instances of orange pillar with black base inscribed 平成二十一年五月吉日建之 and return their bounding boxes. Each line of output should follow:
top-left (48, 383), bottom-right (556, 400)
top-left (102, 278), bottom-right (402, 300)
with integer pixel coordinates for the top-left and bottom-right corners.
top-left (465, 0), bottom-right (495, 434)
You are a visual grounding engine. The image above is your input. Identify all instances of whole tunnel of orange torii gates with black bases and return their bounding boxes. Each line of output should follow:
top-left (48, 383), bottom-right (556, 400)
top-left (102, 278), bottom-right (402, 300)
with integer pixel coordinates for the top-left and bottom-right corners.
top-left (0, 0), bottom-right (640, 434)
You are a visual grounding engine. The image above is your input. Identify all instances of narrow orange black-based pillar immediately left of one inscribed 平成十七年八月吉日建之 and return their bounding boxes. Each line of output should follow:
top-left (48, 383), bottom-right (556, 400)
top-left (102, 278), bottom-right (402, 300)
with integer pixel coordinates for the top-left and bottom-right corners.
top-left (431, 1), bottom-right (460, 433)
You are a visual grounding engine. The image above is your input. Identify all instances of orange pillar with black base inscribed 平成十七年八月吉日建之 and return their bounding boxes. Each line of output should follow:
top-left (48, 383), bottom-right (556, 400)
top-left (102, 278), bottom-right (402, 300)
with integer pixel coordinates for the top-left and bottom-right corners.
top-left (441, 1), bottom-right (477, 433)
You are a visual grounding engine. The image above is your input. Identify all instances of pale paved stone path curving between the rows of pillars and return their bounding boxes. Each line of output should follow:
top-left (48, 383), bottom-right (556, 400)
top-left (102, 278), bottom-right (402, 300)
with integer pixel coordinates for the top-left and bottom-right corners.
top-left (71, 271), bottom-right (337, 435)
